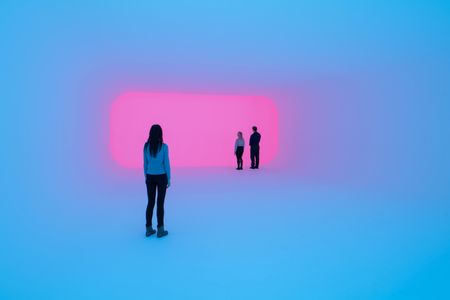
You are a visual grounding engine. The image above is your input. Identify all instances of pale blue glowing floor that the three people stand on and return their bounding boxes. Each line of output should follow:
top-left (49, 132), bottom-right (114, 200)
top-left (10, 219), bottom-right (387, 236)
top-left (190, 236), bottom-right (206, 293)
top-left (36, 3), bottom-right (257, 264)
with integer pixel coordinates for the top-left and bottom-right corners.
top-left (0, 169), bottom-right (450, 299)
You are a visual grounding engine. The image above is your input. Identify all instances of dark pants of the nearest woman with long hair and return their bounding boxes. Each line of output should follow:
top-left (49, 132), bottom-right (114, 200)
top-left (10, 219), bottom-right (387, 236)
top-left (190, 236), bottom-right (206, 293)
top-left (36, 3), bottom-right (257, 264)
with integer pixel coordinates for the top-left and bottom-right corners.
top-left (145, 174), bottom-right (167, 227)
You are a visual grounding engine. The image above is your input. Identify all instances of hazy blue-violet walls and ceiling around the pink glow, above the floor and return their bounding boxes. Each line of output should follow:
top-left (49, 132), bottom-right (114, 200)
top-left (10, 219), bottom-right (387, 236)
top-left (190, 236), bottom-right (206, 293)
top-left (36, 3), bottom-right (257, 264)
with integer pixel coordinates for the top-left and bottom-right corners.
top-left (0, 1), bottom-right (450, 196)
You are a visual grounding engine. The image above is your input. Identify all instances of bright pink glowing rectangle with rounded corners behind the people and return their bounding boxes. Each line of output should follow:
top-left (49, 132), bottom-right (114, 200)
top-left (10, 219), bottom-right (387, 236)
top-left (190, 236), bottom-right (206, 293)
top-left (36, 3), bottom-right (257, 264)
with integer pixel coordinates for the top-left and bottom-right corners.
top-left (110, 92), bottom-right (278, 168)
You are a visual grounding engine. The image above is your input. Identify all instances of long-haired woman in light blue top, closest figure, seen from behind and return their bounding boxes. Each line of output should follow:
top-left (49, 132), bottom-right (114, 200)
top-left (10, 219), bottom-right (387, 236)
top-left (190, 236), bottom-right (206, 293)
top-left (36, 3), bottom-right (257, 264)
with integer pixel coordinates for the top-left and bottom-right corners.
top-left (144, 124), bottom-right (170, 237)
